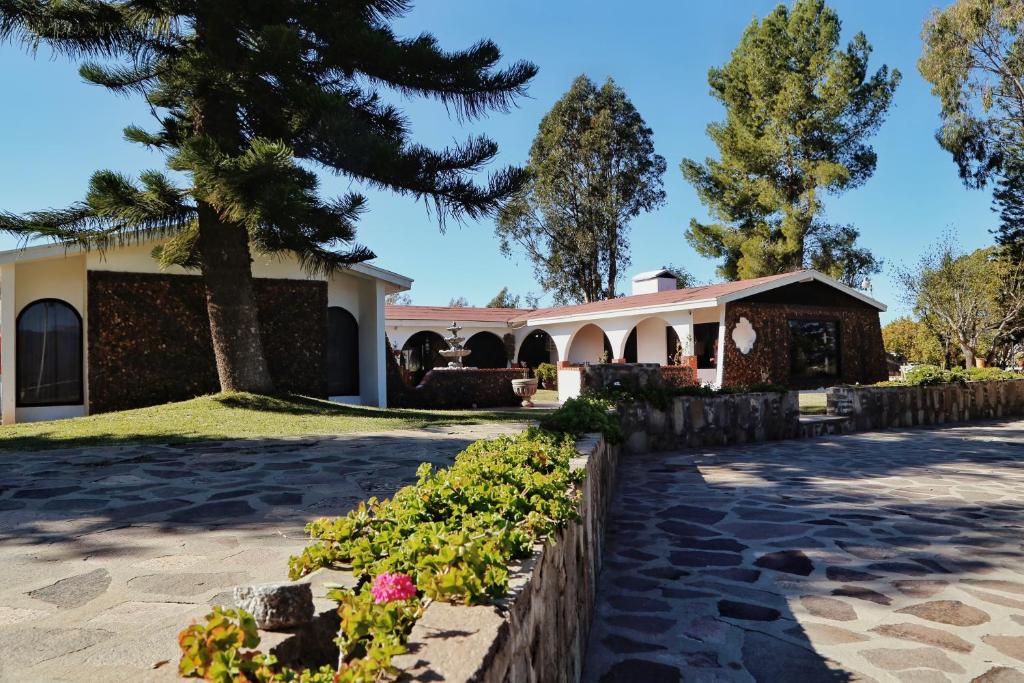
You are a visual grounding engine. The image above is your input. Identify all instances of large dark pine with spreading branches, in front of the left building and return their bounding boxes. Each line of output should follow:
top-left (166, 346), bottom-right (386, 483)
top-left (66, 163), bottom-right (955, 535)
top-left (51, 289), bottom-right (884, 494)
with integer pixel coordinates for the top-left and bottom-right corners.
top-left (0, 0), bottom-right (536, 392)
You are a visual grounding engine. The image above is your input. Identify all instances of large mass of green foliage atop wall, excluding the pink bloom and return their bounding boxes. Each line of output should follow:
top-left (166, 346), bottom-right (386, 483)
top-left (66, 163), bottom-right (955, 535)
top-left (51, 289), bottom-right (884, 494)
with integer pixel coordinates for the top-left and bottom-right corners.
top-left (289, 429), bottom-right (582, 604)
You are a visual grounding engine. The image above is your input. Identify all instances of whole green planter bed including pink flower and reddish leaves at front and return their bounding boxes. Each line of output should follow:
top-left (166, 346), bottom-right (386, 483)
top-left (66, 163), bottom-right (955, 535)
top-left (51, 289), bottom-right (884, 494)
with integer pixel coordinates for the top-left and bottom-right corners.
top-left (179, 429), bottom-right (592, 683)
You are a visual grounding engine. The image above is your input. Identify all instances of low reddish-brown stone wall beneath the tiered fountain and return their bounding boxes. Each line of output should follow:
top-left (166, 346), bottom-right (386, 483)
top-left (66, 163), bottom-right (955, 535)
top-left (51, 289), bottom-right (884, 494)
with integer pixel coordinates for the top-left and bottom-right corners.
top-left (386, 343), bottom-right (523, 409)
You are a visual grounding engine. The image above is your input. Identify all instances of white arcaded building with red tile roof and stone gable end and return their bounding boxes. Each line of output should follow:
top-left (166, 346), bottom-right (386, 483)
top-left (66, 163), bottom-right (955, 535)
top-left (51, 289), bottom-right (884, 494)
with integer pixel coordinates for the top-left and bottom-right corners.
top-left (385, 270), bottom-right (886, 395)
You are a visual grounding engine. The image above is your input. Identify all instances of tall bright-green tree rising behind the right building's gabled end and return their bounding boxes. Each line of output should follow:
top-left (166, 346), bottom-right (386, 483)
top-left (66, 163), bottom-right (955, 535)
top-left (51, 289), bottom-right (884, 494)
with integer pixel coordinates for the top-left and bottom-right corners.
top-left (682, 0), bottom-right (900, 284)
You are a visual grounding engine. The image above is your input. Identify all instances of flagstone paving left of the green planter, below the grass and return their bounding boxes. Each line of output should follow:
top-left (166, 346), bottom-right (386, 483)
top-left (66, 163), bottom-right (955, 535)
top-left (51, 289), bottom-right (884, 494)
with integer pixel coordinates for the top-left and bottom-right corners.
top-left (0, 424), bottom-right (520, 682)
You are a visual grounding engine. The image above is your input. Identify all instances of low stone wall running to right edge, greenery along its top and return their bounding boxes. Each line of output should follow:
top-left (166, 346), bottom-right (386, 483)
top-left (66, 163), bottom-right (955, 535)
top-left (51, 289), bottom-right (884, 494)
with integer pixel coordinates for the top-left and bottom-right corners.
top-left (826, 380), bottom-right (1024, 431)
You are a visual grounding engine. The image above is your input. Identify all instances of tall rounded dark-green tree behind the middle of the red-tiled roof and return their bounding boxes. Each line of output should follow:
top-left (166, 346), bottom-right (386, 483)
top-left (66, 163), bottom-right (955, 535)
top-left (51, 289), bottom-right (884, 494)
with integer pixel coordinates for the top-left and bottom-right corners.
top-left (497, 76), bottom-right (665, 303)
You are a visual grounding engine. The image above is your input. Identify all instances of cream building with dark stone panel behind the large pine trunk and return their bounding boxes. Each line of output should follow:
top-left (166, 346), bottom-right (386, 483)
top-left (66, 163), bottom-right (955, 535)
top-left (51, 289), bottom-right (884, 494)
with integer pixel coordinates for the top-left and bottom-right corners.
top-left (0, 242), bottom-right (412, 424)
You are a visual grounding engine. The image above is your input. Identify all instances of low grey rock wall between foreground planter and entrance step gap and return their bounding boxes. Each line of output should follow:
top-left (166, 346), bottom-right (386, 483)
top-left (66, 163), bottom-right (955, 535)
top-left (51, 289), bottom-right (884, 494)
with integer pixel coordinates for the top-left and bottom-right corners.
top-left (618, 391), bottom-right (801, 453)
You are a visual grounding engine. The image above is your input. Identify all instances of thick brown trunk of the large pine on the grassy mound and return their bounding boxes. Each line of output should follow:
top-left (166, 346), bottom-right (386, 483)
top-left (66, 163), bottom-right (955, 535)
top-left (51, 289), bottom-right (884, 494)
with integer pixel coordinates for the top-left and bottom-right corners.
top-left (199, 202), bottom-right (273, 393)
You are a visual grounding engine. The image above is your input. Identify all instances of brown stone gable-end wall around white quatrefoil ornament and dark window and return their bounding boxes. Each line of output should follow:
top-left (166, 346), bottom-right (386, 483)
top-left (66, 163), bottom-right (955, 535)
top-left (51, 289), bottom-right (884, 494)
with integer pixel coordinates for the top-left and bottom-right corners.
top-left (722, 301), bottom-right (889, 388)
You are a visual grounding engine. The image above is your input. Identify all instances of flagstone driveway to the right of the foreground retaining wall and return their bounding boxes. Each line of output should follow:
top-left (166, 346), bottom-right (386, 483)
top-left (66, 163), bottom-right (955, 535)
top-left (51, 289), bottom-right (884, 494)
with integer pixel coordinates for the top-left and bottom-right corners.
top-left (584, 422), bottom-right (1024, 683)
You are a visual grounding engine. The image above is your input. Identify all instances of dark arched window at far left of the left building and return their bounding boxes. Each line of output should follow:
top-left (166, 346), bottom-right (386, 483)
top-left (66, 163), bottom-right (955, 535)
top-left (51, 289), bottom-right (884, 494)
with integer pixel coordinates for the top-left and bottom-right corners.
top-left (15, 299), bottom-right (83, 405)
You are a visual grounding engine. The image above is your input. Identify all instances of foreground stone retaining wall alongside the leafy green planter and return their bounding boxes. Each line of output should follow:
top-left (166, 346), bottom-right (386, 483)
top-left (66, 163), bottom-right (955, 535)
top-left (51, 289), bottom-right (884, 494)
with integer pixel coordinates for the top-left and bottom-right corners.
top-left (392, 436), bottom-right (618, 683)
